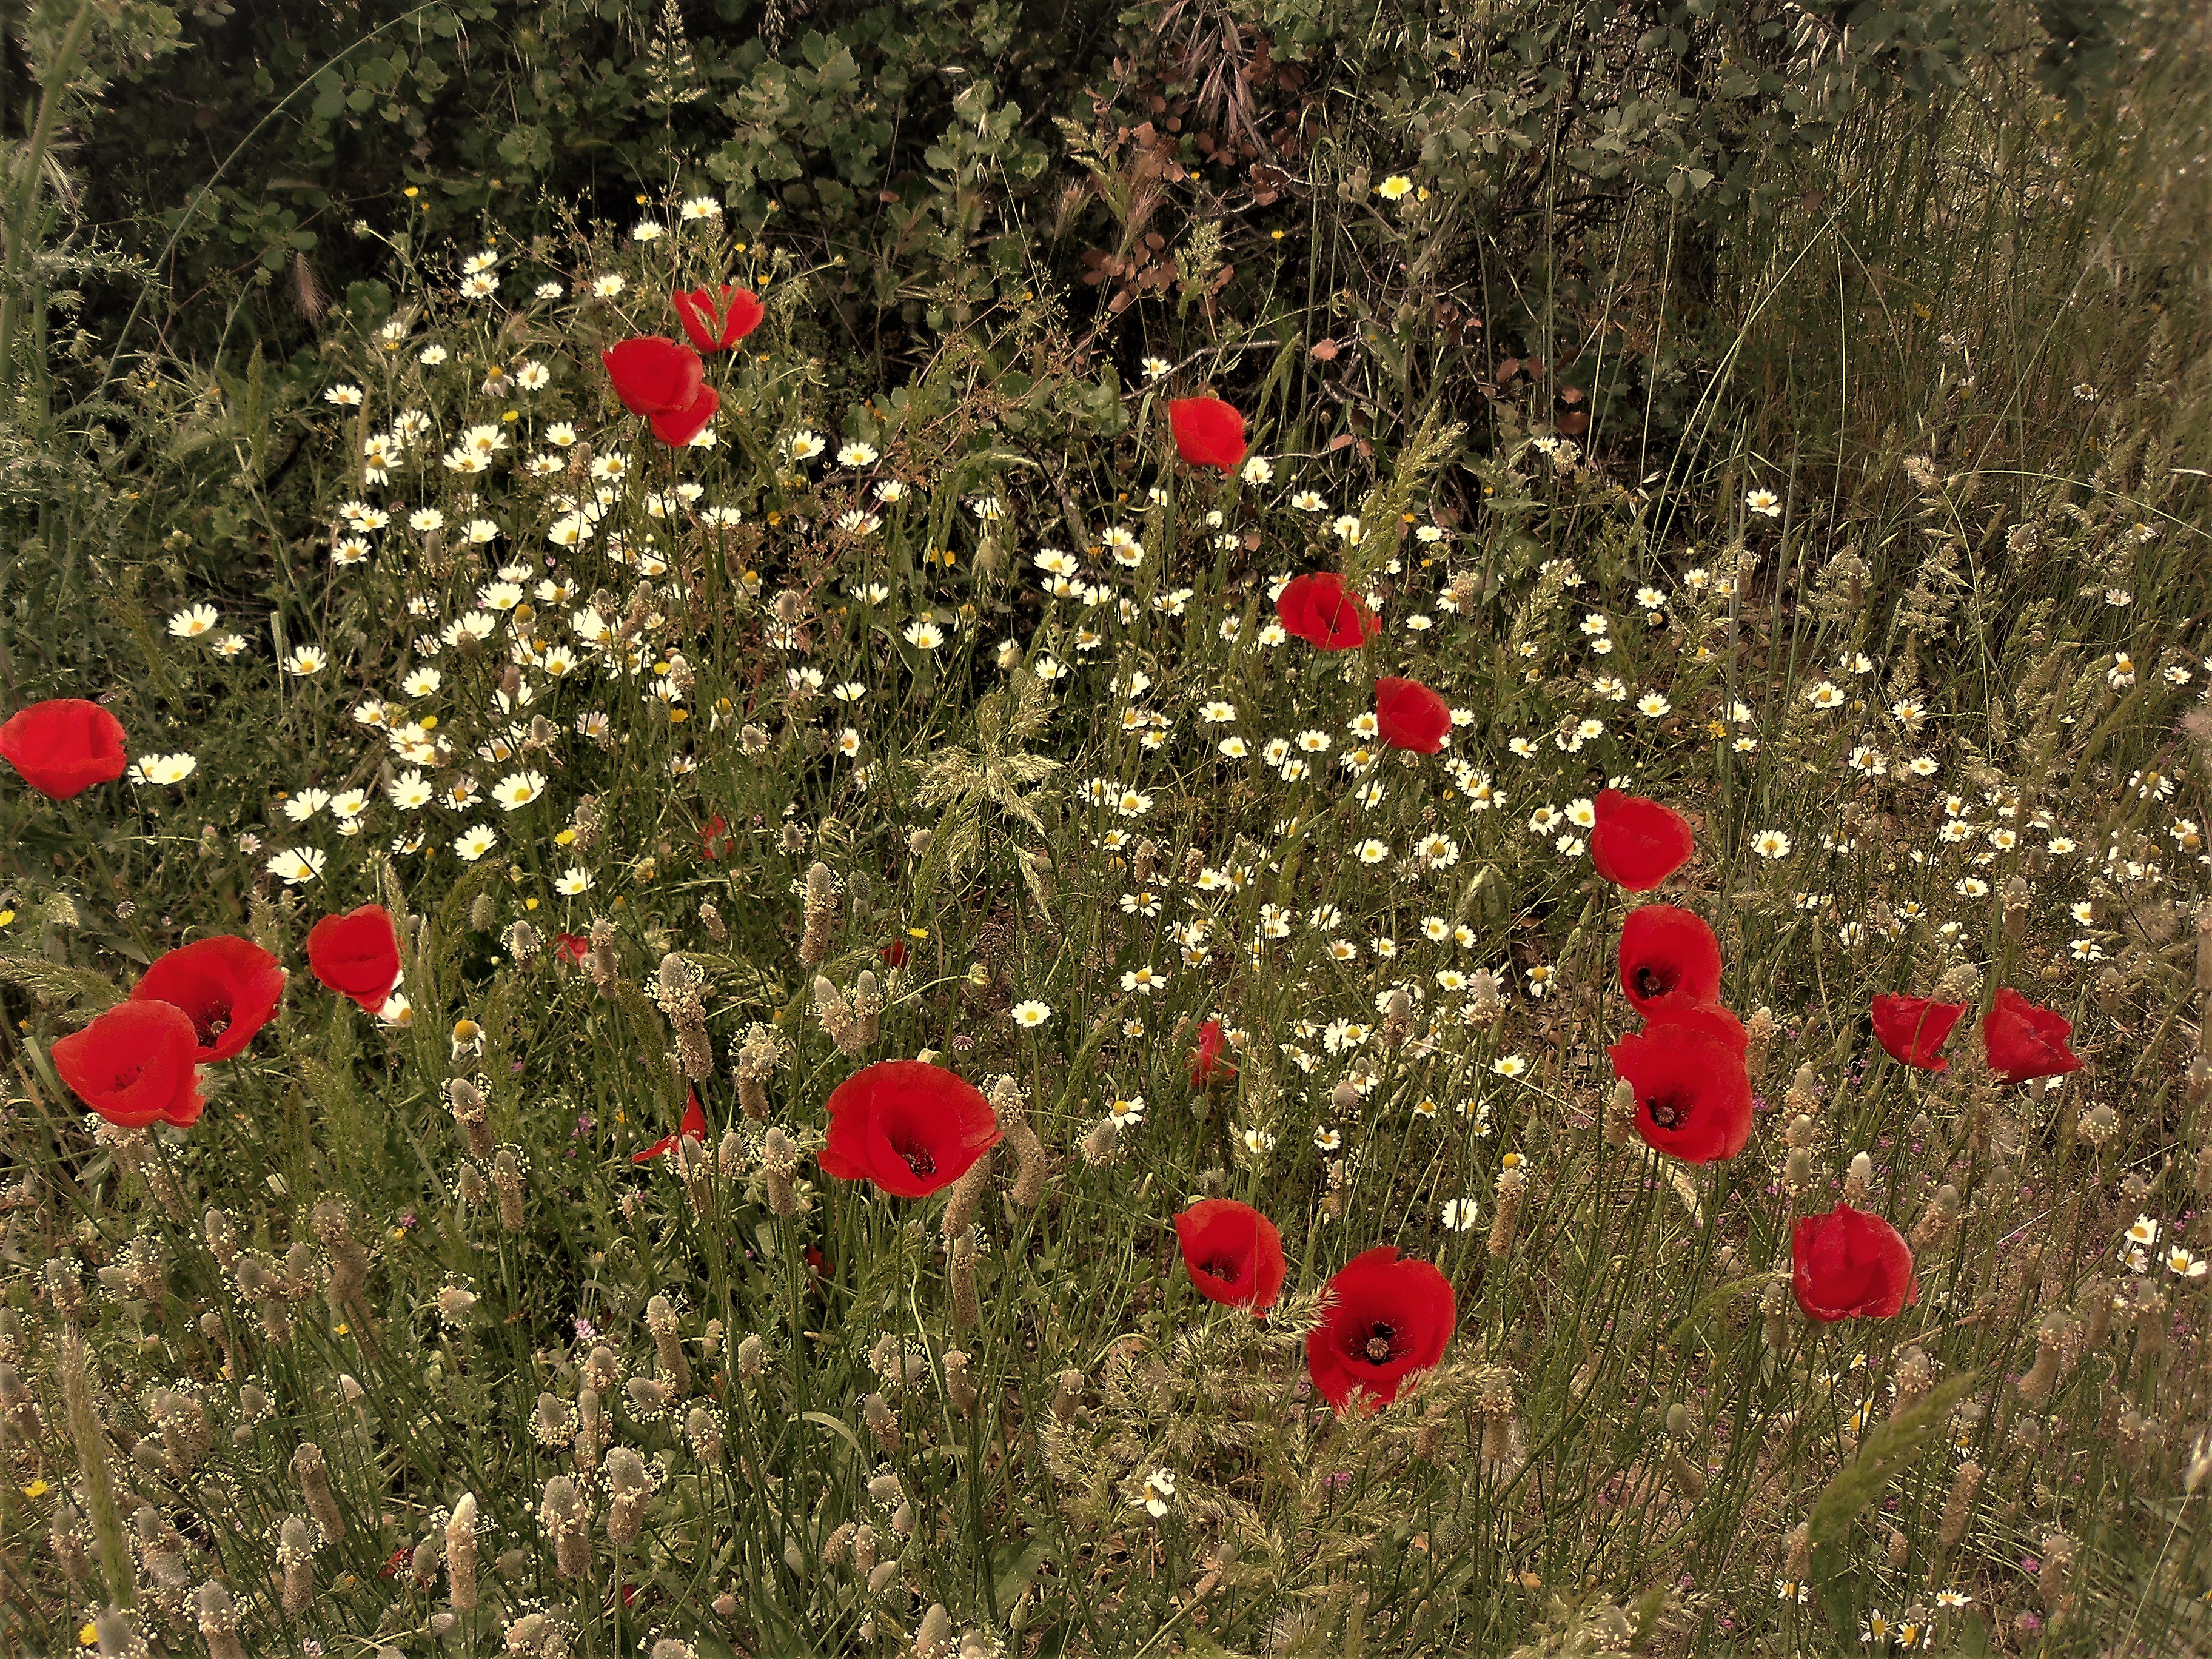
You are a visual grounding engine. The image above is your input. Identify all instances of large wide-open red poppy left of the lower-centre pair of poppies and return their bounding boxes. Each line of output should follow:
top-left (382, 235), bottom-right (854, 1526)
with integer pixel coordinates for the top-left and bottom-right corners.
top-left (820, 1059), bottom-right (997, 1199)
